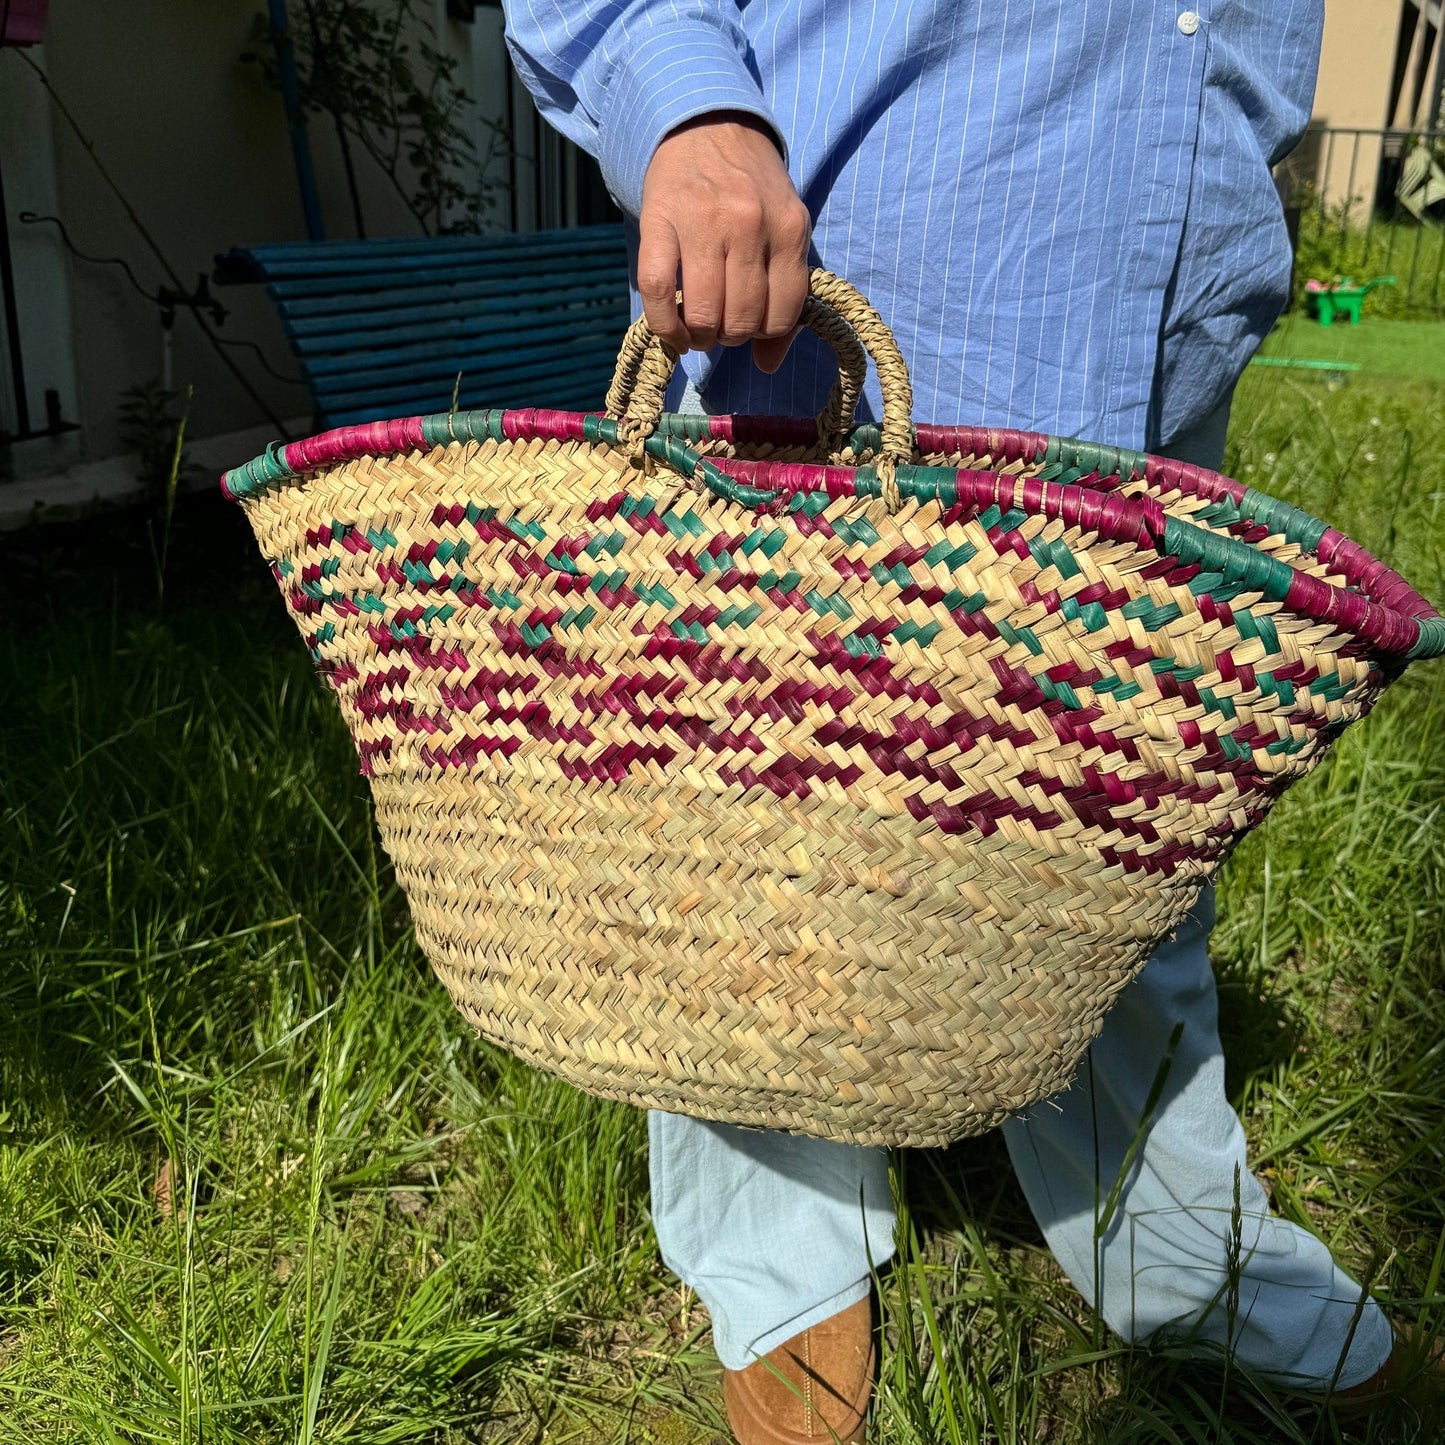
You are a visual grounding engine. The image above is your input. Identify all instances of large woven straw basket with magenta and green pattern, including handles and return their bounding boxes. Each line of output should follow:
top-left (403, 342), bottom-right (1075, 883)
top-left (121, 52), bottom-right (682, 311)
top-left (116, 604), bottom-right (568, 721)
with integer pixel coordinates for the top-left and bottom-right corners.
top-left (224, 272), bottom-right (1445, 1144)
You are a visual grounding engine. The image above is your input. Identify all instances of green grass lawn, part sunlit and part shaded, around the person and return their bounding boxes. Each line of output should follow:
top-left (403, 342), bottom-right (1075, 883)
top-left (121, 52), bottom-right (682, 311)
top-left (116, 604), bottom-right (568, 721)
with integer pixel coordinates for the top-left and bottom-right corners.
top-left (0, 330), bottom-right (1445, 1445)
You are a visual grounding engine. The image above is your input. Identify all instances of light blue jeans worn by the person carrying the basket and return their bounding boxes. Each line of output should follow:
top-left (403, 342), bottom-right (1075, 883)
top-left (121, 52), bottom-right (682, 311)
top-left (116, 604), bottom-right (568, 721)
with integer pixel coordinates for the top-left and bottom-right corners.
top-left (649, 384), bottom-right (1392, 1392)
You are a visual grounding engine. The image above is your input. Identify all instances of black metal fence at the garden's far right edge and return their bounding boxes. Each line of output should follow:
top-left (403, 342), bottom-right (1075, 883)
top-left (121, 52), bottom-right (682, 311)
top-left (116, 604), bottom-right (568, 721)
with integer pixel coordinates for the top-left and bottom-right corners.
top-left (1276, 126), bottom-right (1445, 315)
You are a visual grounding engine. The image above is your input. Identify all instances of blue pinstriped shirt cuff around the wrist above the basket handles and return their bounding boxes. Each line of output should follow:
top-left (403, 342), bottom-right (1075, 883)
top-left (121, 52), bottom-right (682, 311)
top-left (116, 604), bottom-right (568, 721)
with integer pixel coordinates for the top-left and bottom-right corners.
top-left (597, 22), bottom-right (786, 215)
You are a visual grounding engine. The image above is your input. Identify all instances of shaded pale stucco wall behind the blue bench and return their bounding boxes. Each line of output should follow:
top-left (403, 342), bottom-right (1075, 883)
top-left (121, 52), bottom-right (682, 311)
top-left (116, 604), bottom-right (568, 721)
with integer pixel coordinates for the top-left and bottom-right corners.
top-left (0, 0), bottom-right (504, 471)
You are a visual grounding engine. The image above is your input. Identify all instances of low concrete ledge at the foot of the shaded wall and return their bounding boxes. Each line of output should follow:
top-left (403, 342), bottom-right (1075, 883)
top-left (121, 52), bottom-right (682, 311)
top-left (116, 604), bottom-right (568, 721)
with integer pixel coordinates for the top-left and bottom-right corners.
top-left (0, 418), bottom-right (311, 532)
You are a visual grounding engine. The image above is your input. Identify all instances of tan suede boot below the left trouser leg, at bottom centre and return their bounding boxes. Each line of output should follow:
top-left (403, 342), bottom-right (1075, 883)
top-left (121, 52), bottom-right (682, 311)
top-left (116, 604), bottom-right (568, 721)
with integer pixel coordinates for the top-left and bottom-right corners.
top-left (723, 1299), bottom-right (877, 1445)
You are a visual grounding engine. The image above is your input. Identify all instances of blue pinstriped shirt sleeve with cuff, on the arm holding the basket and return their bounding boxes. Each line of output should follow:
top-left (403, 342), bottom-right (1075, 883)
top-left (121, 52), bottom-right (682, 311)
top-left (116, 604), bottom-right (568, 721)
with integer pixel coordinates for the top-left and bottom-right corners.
top-left (504, 0), bottom-right (783, 215)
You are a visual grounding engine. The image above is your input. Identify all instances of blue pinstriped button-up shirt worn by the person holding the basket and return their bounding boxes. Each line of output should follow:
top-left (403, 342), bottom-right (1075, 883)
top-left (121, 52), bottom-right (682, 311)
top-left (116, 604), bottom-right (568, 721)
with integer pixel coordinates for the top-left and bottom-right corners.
top-left (506, 0), bottom-right (1324, 449)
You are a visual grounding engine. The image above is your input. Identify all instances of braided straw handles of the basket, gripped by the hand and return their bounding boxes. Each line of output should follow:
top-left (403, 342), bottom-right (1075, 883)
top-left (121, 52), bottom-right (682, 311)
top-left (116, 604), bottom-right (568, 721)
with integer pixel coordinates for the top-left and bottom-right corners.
top-left (607, 267), bottom-right (913, 481)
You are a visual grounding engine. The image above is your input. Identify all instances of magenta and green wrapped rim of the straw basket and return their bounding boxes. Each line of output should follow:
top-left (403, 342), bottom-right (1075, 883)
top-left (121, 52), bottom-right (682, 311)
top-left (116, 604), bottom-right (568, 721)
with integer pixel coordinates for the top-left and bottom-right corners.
top-left (221, 407), bottom-right (1445, 659)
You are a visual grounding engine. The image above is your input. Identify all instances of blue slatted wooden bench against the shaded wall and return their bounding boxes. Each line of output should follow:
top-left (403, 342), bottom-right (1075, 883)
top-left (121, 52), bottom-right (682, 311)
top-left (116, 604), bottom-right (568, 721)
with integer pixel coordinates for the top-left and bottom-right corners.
top-left (215, 224), bottom-right (630, 426)
